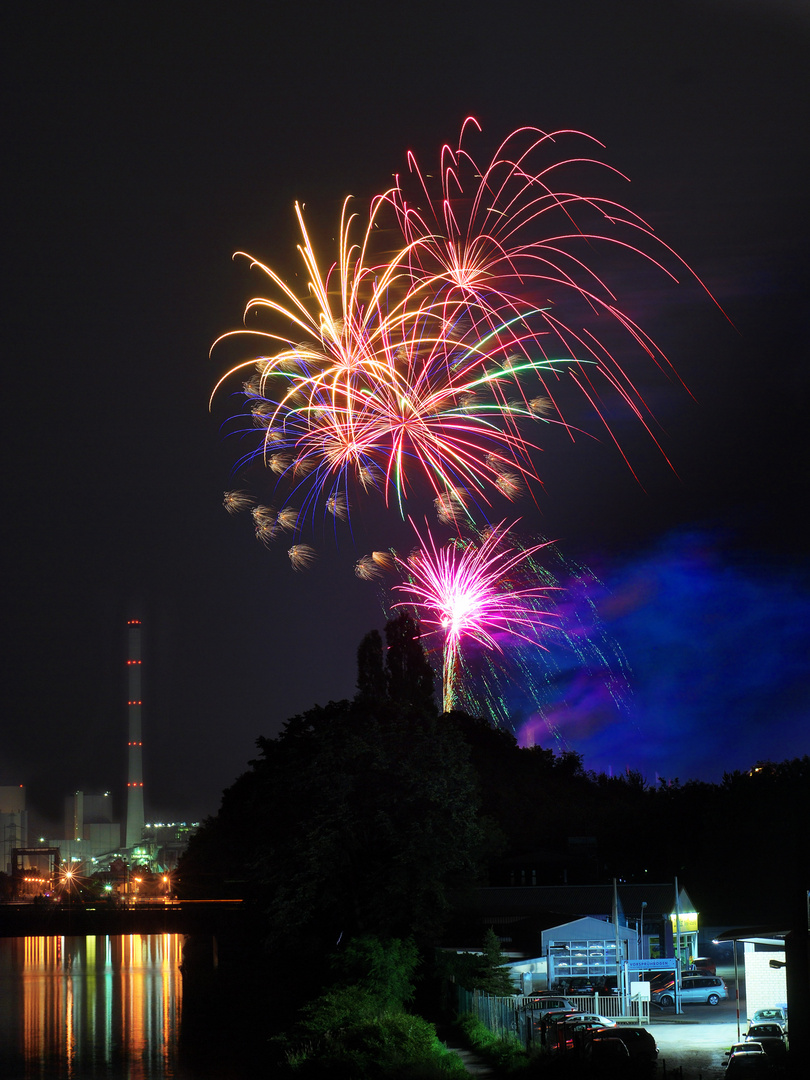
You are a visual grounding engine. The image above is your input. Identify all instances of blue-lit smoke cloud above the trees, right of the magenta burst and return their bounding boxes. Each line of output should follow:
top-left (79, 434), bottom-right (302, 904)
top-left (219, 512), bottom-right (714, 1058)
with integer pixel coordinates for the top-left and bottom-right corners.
top-left (518, 532), bottom-right (810, 782)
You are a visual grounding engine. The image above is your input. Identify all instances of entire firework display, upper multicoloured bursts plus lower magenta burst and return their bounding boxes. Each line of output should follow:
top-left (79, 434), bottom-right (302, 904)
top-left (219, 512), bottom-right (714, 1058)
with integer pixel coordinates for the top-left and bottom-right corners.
top-left (212, 119), bottom-right (708, 724)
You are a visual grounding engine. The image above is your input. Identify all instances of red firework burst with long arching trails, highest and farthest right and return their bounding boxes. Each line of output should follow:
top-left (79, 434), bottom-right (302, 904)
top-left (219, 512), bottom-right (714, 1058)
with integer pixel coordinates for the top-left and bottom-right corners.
top-left (392, 118), bottom-right (721, 473)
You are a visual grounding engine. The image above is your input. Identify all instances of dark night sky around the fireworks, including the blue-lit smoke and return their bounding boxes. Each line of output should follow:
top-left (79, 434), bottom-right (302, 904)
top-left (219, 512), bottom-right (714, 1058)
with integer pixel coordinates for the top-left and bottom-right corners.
top-left (0, 0), bottom-right (810, 819)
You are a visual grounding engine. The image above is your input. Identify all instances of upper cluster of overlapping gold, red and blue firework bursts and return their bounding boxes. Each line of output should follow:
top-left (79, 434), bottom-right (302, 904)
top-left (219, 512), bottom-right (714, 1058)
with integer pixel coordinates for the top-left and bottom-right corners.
top-left (212, 120), bottom-right (721, 561)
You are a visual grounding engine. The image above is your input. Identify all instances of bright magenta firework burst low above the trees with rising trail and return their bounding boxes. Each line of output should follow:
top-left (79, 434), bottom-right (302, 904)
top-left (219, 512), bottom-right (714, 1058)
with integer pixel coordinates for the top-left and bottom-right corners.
top-left (394, 522), bottom-right (554, 712)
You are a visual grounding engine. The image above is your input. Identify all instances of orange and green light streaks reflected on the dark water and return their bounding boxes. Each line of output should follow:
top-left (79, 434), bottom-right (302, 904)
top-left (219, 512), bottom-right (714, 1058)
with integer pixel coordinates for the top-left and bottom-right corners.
top-left (0, 934), bottom-right (183, 1080)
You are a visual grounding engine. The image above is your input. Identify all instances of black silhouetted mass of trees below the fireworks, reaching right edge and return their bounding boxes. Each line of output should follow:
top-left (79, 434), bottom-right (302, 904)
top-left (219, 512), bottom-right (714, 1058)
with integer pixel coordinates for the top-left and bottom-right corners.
top-left (180, 615), bottom-right (810, 956)
